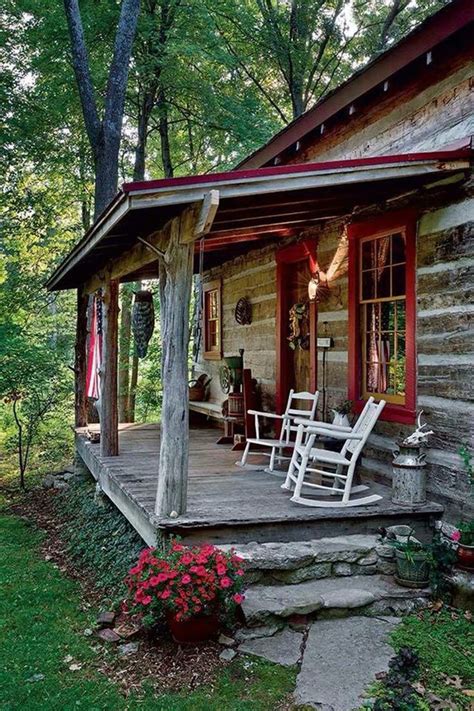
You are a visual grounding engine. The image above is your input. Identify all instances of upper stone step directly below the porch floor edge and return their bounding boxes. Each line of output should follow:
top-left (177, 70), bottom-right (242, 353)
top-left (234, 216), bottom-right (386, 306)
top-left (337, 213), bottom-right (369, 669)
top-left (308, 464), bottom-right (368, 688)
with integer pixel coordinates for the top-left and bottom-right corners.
top-left (221, 534), bottom-right (394, 585)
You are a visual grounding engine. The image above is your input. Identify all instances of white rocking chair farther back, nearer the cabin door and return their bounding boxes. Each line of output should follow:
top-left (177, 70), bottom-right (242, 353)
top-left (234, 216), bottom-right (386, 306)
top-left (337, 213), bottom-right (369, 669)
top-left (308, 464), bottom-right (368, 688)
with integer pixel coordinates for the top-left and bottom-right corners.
top-left (236, 390), bottom-right (319, 476)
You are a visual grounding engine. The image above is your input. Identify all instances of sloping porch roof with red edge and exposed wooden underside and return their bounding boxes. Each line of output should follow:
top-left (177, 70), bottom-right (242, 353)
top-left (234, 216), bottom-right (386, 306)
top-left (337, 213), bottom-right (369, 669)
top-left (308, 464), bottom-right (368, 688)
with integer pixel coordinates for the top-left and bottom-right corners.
top-left (46, 144), bottom-right (472, 290)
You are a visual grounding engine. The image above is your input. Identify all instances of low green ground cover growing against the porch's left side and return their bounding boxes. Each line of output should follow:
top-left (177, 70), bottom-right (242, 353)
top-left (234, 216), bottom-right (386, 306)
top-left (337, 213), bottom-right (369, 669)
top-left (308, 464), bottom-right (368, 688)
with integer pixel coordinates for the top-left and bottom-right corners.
top-left (58, 481), bottom-right (144, 598)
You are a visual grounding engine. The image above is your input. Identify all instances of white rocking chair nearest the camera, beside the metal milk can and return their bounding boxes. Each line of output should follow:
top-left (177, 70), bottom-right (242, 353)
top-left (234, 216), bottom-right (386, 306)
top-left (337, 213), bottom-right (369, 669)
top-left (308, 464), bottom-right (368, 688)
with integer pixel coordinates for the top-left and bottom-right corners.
top-left (281, 397), bottom-right (385, 508)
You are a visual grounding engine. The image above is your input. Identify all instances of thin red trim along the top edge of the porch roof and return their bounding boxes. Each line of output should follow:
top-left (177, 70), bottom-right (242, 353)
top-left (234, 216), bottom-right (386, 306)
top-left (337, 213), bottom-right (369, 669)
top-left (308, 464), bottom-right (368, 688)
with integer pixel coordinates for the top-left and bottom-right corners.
top-left (122, 145), bottom-right (472, 193)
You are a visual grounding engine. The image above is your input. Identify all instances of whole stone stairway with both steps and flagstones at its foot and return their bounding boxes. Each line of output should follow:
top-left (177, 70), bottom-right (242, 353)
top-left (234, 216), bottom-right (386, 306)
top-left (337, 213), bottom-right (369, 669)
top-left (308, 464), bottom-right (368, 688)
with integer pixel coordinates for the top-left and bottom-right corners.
top-left (222, 534), bottom-right (429, 711)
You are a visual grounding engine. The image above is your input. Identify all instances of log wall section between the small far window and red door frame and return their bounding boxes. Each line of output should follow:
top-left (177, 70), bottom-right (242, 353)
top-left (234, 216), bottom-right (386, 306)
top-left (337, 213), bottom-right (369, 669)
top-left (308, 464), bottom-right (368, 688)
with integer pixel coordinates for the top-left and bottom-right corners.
top-left (196, 247), bottom-right (276, 410)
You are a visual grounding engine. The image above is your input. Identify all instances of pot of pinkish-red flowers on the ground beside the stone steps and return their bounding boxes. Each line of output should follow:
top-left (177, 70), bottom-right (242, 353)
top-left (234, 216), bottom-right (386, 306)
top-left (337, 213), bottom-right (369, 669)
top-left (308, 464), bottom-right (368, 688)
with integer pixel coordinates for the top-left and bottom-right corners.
top-left (125, 540), bottom-right (244, 643)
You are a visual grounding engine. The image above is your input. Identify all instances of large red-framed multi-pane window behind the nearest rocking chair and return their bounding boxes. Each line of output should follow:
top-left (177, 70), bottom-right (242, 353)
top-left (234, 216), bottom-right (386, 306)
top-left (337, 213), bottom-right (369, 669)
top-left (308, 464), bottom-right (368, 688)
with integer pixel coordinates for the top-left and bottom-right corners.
top-left (349, 215), bottom-right (416, 422)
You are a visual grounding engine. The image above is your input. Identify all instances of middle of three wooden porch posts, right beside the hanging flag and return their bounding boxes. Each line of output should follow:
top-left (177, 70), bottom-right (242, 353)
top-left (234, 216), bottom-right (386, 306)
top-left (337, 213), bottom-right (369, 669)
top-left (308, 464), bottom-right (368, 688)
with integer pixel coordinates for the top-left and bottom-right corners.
top-left (100, 279), bottom-right (119, 457)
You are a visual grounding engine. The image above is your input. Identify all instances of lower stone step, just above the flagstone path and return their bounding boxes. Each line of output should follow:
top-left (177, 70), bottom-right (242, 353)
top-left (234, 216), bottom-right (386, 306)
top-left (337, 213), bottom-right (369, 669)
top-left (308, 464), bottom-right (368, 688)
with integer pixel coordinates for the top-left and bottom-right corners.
top-left (242, 574), bottom-right (429, 627)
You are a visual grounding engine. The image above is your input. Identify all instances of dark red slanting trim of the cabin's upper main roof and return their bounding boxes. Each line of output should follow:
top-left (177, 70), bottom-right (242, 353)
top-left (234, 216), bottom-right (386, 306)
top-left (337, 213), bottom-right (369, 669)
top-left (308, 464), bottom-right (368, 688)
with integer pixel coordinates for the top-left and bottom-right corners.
top-left (237, 0), bottom-right (474, 168)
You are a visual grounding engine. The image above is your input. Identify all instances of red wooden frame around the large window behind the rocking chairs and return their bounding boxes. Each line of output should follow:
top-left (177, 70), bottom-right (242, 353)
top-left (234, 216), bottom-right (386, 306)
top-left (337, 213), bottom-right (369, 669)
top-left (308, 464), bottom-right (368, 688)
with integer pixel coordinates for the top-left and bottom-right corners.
top-left (347, 210), bottom-right (417, 424)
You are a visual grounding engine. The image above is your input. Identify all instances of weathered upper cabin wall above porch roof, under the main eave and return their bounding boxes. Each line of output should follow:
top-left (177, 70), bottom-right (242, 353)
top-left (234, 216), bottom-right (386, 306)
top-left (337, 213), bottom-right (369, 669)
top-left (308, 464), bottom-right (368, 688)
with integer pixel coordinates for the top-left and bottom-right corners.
top-left (284, 48), bottom-right (474, 163)
